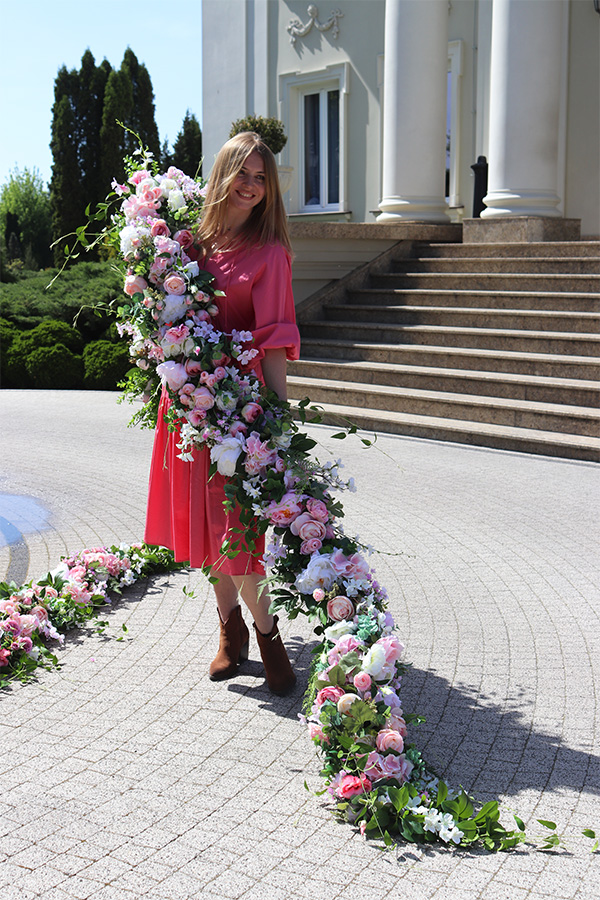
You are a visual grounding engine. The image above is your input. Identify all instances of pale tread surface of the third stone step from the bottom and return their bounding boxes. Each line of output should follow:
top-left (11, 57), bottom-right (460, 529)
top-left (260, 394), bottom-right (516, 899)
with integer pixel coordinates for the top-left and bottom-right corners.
top-left (292, 356), bottom-right (600, 397)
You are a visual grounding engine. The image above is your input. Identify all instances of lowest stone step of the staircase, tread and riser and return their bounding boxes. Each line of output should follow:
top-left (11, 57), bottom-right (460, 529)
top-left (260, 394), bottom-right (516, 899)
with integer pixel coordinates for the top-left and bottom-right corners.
top-left (292, 403), bottom-right (600, 462)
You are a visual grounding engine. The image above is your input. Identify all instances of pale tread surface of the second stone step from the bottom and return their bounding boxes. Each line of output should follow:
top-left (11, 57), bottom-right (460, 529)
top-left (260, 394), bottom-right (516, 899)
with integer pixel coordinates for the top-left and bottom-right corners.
top-left (288, 375), bottom-right (600, 421)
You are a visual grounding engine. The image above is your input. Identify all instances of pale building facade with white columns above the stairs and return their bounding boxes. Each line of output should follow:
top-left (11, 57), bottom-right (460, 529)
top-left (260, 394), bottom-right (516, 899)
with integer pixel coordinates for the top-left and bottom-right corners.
top-left (202, 0), bottom-right (600, 290)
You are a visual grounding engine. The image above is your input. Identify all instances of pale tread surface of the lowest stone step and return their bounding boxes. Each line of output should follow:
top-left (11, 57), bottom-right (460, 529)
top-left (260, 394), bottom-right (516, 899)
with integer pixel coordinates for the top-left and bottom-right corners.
top-left (298, 403), bottom-right (600, 456)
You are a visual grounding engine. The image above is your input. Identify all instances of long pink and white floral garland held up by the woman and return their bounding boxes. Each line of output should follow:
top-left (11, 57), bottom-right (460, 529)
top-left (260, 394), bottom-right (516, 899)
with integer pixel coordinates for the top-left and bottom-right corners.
top-left (17, 149), bottom-right (589, 849)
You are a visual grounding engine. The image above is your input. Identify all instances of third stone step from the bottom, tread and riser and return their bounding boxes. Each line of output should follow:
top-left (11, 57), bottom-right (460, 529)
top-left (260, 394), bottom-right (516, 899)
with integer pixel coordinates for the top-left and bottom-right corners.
top-left (288, 358), bottom-right (600, 409)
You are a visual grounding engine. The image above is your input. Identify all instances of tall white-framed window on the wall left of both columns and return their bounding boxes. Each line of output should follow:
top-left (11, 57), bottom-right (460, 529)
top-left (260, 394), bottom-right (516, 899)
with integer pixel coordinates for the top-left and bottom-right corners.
top-left (279, 63), bottom-right (349, 214)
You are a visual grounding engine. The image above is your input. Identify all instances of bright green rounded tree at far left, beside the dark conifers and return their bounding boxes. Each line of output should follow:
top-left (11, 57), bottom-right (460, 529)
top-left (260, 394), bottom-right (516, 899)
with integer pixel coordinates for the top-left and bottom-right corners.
top-left (0, 168), bottom-right (52, 268)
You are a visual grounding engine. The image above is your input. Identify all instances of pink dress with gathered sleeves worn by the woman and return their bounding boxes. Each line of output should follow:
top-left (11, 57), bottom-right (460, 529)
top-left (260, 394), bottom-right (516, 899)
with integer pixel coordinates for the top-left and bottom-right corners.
top-left (144, 244), bottom-right (300, 575)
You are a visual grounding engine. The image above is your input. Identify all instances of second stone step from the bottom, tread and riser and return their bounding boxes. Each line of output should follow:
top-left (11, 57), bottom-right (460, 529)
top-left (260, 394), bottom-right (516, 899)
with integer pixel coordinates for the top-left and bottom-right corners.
top-left (288, 376), bottom-right (600, 437)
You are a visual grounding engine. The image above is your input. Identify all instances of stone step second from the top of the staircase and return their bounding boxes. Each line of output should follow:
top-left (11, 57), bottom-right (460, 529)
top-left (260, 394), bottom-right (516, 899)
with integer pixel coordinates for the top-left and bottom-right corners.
top-left (392, 256), bottom-right (600, 276)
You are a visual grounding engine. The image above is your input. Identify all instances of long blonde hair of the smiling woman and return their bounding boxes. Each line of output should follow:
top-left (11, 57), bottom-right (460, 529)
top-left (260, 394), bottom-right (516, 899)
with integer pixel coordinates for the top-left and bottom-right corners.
top-left (196, 131), bottom-right (292, 255)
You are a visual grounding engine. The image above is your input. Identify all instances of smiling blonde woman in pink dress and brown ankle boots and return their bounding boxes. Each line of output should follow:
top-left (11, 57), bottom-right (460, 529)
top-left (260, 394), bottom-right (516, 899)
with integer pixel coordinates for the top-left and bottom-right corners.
top-left (145, 132), bottom-right (300, 694)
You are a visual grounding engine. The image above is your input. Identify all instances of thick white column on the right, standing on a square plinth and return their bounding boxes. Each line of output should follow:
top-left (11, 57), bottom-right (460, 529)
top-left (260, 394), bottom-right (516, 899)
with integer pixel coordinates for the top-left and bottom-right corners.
top-left (481, 0), bottom-right (566, 218)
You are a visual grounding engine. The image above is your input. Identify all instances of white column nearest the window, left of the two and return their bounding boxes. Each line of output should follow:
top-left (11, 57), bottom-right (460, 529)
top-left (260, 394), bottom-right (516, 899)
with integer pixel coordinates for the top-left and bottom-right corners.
top-left (377, 0), bottom-right (448, 222)
